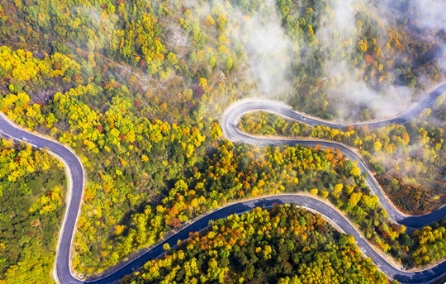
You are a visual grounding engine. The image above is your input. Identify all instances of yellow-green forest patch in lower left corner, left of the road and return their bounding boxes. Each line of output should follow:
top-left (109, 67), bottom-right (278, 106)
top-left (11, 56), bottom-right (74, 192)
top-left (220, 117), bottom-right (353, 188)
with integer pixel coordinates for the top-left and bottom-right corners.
top-left (0, 139), bottom-right (66, 284)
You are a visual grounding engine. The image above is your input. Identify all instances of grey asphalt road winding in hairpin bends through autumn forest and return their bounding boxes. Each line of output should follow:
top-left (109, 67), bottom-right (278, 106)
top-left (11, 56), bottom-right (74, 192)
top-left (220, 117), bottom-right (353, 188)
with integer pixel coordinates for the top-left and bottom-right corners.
top-left (0, 84), bottom-right (446, 283)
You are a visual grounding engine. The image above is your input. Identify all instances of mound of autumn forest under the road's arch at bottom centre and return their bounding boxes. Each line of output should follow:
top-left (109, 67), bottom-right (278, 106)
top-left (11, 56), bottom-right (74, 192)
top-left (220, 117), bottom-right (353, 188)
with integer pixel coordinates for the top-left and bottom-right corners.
top-left (123, 205), bottom-right (389, 284)
